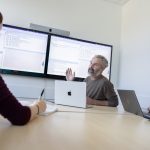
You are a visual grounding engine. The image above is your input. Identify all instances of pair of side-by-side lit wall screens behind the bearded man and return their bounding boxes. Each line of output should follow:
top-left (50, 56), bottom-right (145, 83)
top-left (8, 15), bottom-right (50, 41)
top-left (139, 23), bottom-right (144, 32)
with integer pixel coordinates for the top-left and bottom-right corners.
top-left (0, 24), bottom-right (112, 79)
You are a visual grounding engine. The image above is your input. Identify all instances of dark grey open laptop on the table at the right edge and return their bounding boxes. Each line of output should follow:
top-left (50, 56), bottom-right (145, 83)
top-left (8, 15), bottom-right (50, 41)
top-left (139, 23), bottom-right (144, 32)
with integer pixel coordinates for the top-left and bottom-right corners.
top-left (117, 89), bottom-right (150, 119)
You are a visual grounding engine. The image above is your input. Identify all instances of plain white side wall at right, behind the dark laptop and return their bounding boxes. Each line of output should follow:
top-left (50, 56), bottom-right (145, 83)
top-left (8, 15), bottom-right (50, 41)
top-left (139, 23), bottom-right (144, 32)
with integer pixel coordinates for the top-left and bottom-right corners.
top-left (119, 0), bottom-right (150, 107)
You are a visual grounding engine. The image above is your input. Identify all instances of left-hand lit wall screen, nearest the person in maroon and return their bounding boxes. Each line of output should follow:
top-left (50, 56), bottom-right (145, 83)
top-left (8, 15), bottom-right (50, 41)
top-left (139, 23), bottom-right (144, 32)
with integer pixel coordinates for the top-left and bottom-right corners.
top-left (0, 25), bottom-right (48, 74)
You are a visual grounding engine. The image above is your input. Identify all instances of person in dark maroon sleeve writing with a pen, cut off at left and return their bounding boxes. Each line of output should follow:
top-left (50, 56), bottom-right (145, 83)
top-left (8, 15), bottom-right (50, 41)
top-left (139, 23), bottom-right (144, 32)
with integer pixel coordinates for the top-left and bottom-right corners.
top-left (0, 12), bottom-right (46, 125)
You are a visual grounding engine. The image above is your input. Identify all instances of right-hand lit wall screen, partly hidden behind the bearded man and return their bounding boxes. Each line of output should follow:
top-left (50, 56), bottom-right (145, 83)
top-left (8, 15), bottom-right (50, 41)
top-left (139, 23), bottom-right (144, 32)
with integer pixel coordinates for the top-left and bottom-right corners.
top-left (47, 35), bottom-right (112, 79)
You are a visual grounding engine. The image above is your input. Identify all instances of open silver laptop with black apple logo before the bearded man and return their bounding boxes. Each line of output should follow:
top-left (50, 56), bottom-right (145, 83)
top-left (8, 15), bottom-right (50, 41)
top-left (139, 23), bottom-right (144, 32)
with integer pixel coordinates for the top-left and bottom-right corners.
top-left (55, 80), bottom-right (86, 108)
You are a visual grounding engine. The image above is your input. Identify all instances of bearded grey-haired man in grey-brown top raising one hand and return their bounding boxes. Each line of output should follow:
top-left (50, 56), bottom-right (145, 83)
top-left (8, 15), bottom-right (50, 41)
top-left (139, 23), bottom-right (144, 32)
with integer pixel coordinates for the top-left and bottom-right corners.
top-left (66, 55), bottom-right (118, 107)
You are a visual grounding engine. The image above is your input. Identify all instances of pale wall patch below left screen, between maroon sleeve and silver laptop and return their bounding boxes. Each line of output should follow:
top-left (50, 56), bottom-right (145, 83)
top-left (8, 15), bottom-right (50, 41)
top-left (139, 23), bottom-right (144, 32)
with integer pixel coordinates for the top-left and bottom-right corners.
top-left (2, 75), bottom-right (54, 100)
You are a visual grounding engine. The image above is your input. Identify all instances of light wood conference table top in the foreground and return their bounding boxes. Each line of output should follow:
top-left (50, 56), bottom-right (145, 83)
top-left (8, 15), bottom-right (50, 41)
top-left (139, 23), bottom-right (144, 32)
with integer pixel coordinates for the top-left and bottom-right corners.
top-left (0, 101), bottom-right (150, 150)
